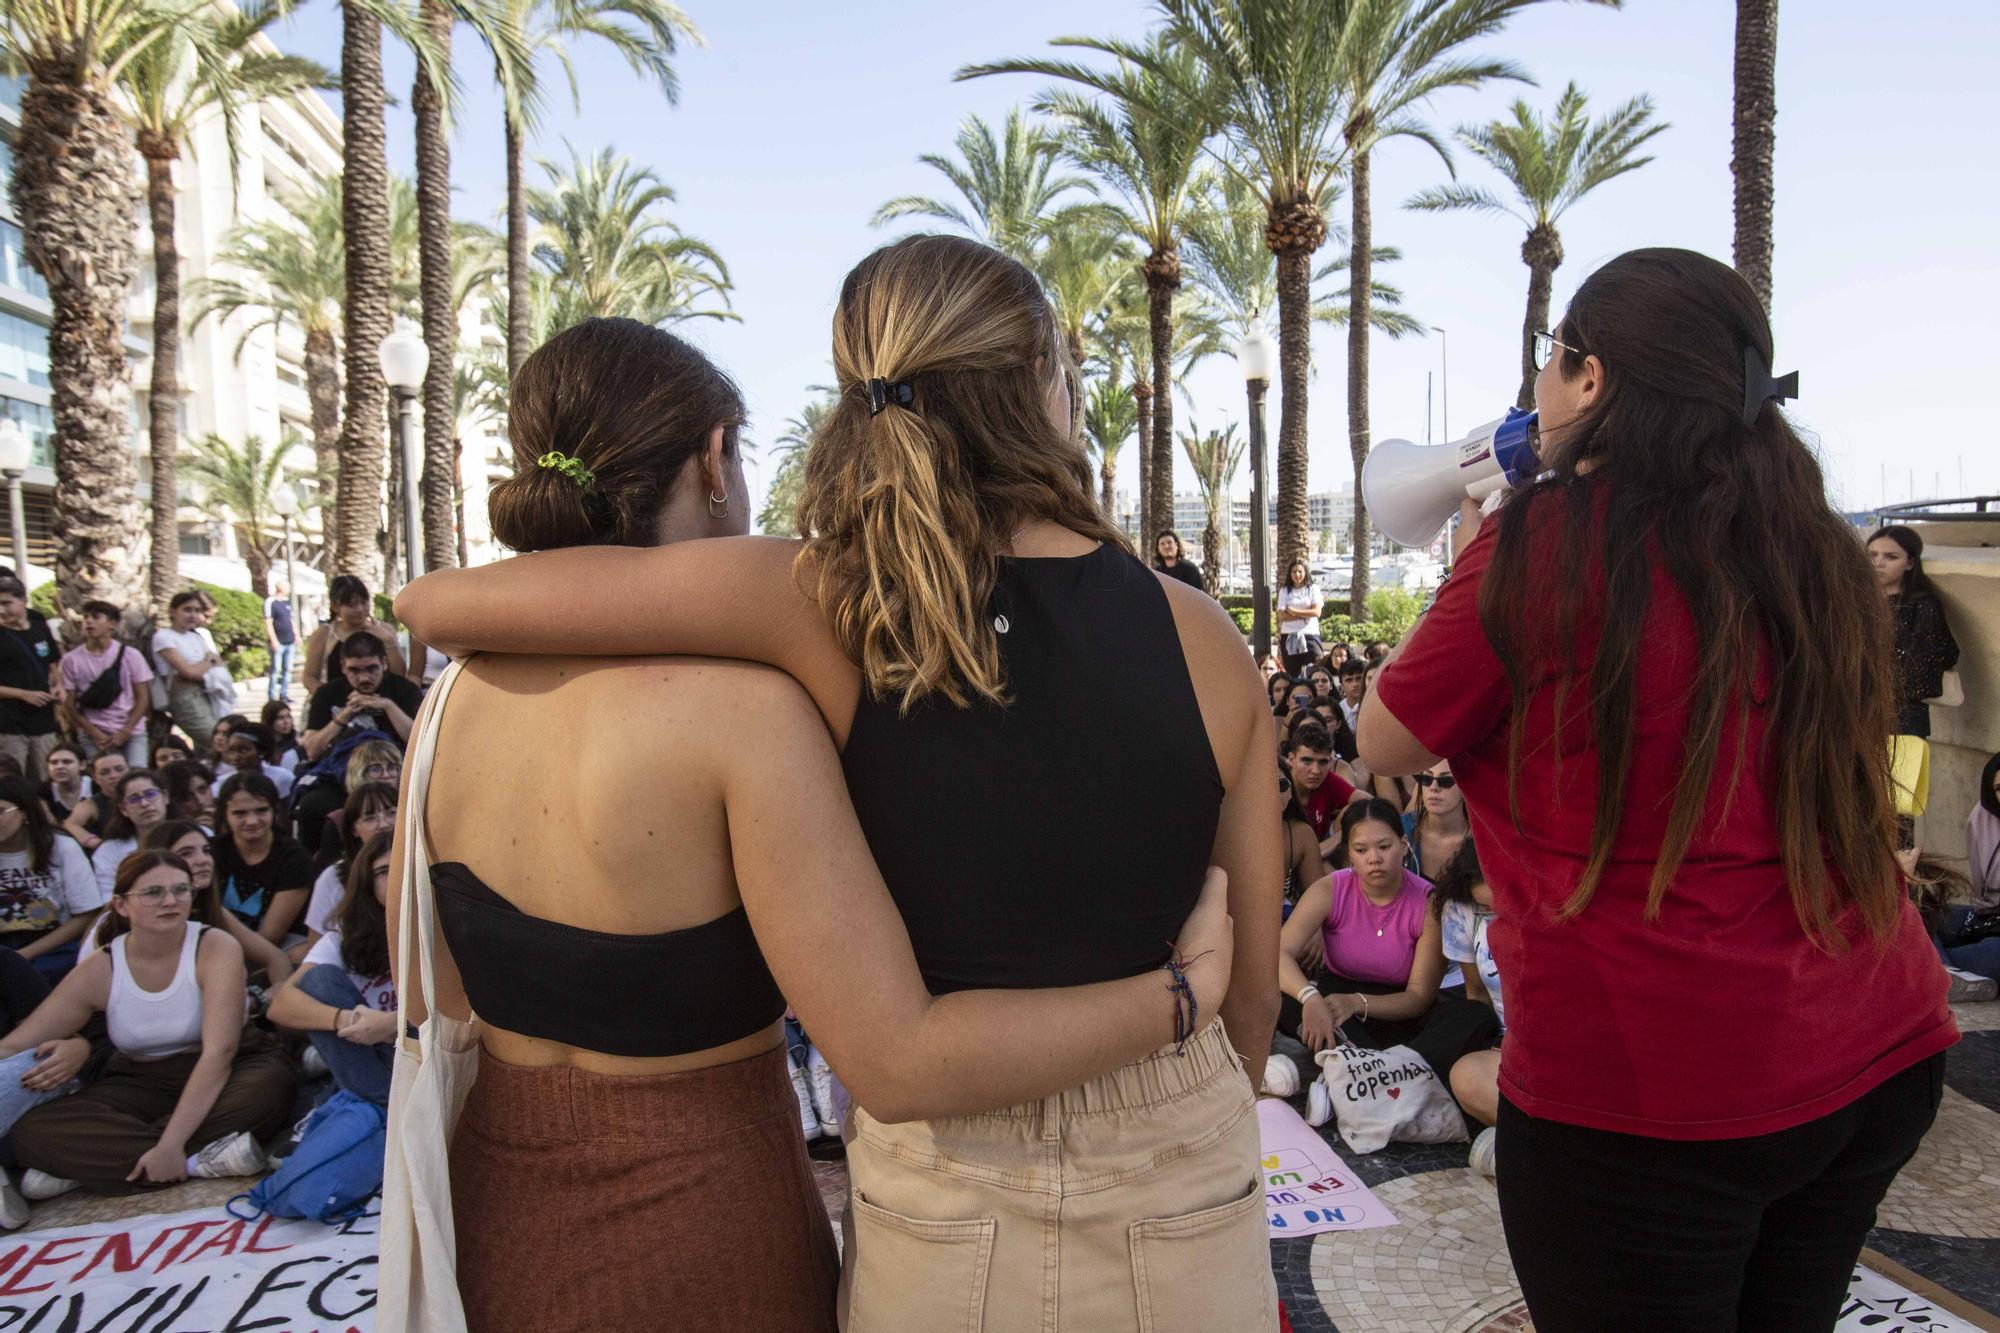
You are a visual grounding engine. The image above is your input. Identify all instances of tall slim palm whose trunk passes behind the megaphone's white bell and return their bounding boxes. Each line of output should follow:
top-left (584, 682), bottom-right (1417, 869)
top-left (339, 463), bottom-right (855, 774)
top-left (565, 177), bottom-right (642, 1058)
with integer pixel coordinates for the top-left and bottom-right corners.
top-left (1330, 0), bottom-right (1544, 606)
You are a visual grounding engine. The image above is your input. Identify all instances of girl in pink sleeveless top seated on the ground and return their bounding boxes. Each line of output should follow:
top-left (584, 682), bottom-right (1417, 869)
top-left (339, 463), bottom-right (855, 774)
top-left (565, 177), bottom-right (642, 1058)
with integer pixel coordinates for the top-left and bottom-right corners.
top-left (1278, 799), bottom-right (1500, 1120)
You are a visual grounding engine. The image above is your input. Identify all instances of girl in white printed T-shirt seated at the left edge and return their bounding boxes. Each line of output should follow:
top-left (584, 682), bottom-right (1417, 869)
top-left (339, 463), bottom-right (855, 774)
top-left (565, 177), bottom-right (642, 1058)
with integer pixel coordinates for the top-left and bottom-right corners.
top-left (0, 777), bottom-right (104, 985)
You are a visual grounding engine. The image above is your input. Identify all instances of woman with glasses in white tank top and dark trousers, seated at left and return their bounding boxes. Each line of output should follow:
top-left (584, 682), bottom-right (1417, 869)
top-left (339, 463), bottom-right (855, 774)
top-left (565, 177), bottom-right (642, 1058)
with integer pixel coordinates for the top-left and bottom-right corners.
top-left (0, 851), bottom-right (292, 1199)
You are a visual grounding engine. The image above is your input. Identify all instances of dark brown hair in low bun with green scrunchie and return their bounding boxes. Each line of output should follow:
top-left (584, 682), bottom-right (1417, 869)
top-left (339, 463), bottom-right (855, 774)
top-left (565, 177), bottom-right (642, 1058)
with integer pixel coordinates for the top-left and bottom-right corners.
top-left (486, 318), bottom-right (744, 550)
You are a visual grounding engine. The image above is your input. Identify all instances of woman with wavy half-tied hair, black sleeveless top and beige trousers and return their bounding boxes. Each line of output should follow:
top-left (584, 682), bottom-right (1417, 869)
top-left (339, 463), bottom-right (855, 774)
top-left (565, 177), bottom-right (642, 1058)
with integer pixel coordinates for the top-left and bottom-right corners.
top-left (398, 236), bottom-right (1284, 1333)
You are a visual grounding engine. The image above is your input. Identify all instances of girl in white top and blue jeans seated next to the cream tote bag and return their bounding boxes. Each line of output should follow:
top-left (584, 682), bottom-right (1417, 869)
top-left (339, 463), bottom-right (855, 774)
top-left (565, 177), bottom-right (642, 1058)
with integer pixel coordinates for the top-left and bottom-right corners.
top-left (270, 832), bottom-right (396, 1107)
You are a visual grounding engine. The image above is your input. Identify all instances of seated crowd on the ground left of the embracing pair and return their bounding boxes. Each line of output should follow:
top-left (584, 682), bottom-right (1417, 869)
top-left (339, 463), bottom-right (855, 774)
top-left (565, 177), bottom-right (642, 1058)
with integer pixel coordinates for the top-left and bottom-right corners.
top-left (0, 580), bottom-right (422, 1229)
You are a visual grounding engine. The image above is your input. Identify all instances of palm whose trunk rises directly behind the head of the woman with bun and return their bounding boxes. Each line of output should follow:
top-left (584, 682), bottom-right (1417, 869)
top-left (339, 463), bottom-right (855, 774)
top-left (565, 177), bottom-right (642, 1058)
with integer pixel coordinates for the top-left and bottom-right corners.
top-left (480, 0), bottom-right (702, 378)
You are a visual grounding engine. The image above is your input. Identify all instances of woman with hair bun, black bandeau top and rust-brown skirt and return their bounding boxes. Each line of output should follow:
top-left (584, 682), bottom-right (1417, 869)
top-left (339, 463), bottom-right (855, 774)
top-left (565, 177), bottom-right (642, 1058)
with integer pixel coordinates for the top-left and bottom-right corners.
top-left (384, 320), bottom-right (1240, 1333)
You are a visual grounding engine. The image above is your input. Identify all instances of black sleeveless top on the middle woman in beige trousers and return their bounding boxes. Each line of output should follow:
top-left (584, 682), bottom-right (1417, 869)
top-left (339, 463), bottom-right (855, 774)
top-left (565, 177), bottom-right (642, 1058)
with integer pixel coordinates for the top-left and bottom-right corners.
top-left (842, 546), bottom-right (1222, 995)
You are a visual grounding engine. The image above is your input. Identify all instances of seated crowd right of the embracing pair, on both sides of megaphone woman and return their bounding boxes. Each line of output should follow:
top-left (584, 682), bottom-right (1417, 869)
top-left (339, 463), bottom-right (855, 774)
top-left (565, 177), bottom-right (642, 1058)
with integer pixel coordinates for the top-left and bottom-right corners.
top-left (1264, 642), bottom-right (2000, 1177)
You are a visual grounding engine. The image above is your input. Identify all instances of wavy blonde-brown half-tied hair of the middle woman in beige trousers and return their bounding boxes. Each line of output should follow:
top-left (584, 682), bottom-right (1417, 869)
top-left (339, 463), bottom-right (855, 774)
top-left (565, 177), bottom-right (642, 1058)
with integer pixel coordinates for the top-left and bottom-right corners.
top-left (798, 236), bottom-right (1128, 709)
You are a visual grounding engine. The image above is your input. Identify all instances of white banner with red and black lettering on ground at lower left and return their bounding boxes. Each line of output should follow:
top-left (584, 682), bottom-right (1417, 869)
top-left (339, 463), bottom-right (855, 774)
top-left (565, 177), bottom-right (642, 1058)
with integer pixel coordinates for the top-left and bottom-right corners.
top-left (0, 1209), bottom-right (376, 1333)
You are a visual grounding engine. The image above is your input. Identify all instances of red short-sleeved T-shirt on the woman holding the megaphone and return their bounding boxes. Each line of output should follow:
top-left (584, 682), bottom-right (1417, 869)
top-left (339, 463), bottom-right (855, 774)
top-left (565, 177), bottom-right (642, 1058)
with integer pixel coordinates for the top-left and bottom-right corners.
top-left (1376, 496), bottom-right (1958, 1139)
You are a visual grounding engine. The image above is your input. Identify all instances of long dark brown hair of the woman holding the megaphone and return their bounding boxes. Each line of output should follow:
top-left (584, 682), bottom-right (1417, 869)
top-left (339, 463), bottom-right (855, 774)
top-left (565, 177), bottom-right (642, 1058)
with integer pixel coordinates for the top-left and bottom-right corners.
top-left (1480, 248), bottom-right (1902, 949)
